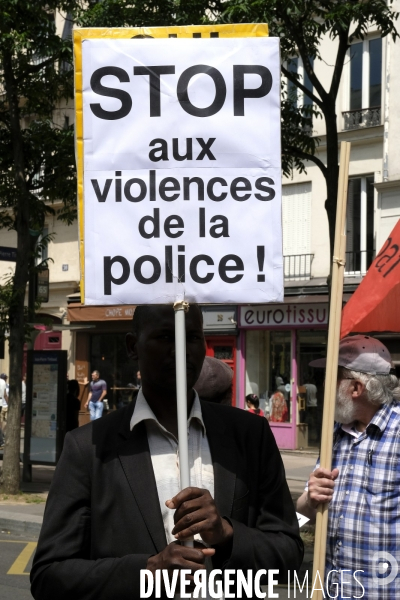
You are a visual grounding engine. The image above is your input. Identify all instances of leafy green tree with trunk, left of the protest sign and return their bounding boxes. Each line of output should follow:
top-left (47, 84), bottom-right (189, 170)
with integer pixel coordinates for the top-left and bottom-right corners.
top-left (0, 0), bottom-right (78, 494)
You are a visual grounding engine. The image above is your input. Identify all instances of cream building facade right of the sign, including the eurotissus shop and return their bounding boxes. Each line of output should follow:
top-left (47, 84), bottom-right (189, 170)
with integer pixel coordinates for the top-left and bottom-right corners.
top-left (238, 7), bottom-right (400, 449)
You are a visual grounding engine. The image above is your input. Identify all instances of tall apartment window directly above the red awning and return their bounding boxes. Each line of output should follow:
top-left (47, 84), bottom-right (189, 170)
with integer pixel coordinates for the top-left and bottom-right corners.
top-left (346, 176), bottom-right (374, 275)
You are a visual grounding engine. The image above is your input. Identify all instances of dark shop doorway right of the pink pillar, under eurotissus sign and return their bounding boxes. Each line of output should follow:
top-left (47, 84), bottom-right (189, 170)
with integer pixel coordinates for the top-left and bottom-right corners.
top-left (297, 331), bottom-right (328, 448)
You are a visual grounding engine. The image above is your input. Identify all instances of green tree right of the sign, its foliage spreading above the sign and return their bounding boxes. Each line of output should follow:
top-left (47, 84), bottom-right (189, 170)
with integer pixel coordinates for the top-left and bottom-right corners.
top-left (77, 0), bottom-right (398, 253)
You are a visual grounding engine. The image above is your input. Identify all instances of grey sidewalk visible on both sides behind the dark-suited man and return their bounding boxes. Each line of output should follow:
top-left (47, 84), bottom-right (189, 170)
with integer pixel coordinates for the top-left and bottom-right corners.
top-left (0, 450), bottom-right (318, 535)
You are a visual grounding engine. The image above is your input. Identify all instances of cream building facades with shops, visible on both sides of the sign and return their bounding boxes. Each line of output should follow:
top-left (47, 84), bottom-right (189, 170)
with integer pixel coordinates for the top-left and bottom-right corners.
top-left (0, 8), bottom-right (400, 449)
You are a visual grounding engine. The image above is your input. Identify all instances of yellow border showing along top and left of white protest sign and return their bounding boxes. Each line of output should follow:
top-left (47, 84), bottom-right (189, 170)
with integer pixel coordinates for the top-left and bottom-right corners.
top-left (73, 23), bottom-right (269, 301)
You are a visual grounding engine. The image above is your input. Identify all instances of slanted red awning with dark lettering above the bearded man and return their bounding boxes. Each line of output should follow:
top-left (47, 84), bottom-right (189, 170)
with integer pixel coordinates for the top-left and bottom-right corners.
top-left (340, 219), bottom-right (400, 337)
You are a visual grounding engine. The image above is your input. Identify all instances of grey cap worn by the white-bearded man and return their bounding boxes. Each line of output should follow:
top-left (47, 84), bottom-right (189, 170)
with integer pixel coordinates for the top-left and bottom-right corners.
top-left (309, 335), bottom-right (392, 375)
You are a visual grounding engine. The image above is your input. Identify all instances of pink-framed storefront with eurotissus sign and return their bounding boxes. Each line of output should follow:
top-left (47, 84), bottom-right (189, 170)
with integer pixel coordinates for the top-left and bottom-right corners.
top-left (239, 302), bottom-right (328, 450)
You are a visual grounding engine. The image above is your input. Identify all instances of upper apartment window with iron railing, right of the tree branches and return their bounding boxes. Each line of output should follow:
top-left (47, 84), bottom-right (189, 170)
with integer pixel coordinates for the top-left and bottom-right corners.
top-left (343, 38), bottom-right (382, 129)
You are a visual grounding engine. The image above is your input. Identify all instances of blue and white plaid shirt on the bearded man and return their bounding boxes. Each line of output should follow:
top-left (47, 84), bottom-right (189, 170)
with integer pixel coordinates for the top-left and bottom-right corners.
top-left (326, 401), bottom-right (400, 600)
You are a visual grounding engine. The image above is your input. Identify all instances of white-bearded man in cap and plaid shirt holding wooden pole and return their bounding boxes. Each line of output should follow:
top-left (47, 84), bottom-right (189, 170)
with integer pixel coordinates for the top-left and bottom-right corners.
top-left (297, 335), bottom-right (400, 600)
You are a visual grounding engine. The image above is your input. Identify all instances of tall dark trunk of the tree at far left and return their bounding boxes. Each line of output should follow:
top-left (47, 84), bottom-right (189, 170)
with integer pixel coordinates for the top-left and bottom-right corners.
top-left (0, 49), bottom-right (31, 494)
